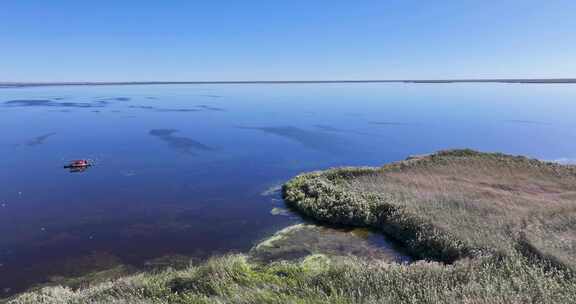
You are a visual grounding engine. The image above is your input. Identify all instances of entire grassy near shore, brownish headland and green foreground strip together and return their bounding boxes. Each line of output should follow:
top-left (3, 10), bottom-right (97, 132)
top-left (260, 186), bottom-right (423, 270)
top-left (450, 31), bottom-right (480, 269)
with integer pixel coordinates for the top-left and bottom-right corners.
top-left (10, 150), bottom-right (576, 303)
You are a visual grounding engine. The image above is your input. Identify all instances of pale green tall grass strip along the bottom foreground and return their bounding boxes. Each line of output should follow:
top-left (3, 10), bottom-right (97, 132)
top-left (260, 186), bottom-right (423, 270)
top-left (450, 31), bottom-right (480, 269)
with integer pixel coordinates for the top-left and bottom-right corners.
top-left (9, 255), bottom-right (576, 304)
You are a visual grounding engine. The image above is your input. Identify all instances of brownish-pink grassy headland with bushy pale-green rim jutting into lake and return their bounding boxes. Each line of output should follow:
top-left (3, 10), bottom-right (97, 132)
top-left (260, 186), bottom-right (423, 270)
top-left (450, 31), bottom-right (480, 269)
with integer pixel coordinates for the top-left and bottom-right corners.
top-left (283, 150), bottom-right (576, 268)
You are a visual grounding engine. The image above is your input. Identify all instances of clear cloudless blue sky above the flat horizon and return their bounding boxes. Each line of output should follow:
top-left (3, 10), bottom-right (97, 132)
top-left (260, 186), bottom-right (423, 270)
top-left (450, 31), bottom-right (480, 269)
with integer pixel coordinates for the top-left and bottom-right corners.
top-left (0, 0), bottom-right (576, 81)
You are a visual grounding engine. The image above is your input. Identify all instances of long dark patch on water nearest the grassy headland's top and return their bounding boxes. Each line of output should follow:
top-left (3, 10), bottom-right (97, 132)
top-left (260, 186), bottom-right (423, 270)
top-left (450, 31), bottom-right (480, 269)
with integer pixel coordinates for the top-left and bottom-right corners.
top-left (239, 126), bottom-right (342, 152)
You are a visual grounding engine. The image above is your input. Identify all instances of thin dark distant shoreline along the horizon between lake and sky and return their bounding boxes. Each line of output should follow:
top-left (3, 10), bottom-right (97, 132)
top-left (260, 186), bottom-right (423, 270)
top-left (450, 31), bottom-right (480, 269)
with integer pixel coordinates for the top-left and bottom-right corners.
top-left (0, 78), bottom-right (576, 88)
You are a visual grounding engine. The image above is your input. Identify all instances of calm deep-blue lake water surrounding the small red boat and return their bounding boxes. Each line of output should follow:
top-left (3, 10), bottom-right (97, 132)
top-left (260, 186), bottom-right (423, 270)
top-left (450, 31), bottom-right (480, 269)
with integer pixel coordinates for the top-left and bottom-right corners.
top-left (0, 84), bottom-right (576, 295)
